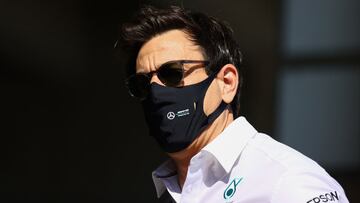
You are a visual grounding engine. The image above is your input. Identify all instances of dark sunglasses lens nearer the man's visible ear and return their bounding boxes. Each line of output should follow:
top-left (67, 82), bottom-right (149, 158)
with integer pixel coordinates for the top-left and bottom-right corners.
top-left (157, 62), bottom-right (183, 87)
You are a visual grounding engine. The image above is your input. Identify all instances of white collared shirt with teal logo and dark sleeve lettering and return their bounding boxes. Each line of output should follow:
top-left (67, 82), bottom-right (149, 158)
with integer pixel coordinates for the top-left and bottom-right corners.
top-left (153, 117), bottom-right (348, 203)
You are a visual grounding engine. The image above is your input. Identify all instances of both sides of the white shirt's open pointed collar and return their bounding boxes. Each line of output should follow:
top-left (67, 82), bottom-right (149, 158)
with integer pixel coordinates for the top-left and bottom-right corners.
top-left (152, 117), bottom-right (257, 197)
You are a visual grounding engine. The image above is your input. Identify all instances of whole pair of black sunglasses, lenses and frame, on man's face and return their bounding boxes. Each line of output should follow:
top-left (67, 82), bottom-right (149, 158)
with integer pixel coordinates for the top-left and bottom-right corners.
top-left (125, 60), bottom-right (209, 99)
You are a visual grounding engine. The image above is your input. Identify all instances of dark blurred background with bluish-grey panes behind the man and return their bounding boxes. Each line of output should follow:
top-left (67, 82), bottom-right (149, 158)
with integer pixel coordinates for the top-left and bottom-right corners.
top-left (0, 0), bottom-right (360, 203)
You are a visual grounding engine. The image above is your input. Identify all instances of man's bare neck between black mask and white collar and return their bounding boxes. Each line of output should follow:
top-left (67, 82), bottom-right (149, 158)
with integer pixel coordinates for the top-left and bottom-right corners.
top-left (169, 108), bottom-right (234, 188)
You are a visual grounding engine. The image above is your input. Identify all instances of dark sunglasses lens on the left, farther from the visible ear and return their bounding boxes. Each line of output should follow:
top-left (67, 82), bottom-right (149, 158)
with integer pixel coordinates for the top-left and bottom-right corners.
top-left (127, 74), bottom-right (150, 99)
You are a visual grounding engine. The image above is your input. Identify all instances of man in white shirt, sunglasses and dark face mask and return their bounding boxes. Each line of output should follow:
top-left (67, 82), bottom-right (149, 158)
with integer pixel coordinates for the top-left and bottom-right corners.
top-left (121, 4), bottom-right (348, 203)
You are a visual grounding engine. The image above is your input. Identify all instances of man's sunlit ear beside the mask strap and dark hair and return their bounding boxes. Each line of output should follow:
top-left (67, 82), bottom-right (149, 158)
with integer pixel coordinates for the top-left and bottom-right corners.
top-left (216, 64), bottom-right (239, 104)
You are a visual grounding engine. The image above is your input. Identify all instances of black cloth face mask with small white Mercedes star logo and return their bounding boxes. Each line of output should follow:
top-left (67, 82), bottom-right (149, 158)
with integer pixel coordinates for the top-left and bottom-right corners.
top-left (142, 74), bottom-right (227, 153)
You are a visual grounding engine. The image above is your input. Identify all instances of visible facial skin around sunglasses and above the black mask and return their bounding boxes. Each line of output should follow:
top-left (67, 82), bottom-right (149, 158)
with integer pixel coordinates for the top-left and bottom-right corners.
top-left (136, 30), bottom-right (221, 115)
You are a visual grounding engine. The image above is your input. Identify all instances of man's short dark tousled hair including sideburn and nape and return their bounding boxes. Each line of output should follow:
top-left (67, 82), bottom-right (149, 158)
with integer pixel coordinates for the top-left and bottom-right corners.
top-left (119, 6), bottom-right (242, 117)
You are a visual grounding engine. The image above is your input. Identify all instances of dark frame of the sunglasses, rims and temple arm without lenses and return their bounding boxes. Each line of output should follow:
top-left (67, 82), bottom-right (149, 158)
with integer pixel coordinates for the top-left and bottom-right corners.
top-left (125, 60), bottom-right (209, 100)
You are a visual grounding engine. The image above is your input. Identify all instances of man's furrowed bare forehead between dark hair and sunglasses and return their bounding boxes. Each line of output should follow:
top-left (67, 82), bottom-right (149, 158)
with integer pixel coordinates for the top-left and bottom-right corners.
top-left (136, 30), bottom-right (204, 70)
